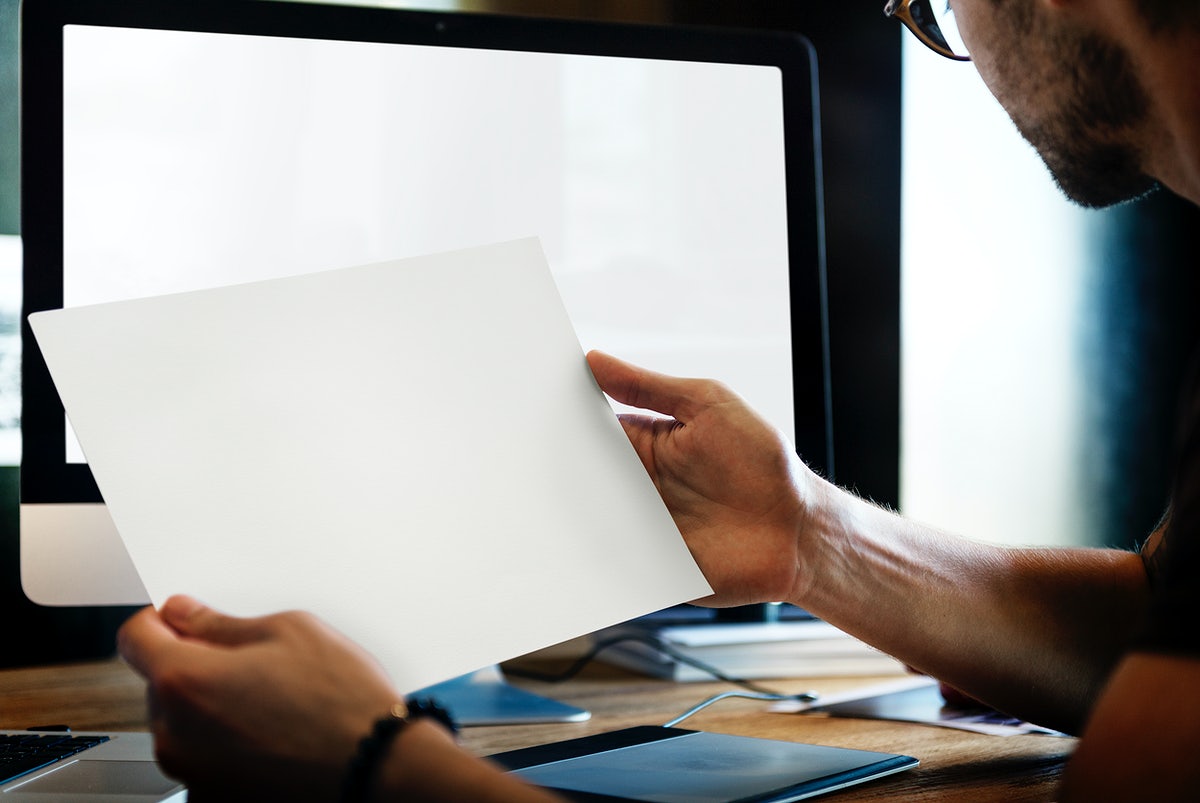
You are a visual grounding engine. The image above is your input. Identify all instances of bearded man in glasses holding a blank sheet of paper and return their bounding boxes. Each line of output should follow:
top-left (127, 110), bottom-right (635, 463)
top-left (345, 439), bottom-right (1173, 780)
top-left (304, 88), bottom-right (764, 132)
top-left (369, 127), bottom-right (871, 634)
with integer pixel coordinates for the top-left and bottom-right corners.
top-left (114, 0), bottom-right (1200, 801)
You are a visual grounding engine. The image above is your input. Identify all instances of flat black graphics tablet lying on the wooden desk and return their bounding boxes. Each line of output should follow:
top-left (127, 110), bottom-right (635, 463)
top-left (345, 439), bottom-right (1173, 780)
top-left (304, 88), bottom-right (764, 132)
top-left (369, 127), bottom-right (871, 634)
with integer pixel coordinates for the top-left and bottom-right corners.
top-left (491, 725), bottom-right (918, 803)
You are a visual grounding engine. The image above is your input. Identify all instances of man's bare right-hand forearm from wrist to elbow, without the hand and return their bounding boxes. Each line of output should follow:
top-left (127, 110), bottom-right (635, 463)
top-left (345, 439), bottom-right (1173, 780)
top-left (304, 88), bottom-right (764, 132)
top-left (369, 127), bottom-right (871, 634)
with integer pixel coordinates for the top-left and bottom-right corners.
top-left (793, 475), bottom-right (1147, 732)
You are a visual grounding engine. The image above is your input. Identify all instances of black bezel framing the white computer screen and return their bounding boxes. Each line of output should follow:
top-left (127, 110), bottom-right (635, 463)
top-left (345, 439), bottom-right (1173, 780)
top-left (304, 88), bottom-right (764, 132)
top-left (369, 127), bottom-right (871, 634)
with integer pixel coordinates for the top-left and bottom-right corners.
top-left (20, 0), bottom-right (834, 504)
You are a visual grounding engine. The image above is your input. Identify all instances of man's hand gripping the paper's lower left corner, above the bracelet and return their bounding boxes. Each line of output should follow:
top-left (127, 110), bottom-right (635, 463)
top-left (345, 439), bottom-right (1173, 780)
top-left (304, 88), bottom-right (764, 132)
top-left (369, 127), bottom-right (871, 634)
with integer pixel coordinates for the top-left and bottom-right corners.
top-left (119, 597), bottom-right (401, 801)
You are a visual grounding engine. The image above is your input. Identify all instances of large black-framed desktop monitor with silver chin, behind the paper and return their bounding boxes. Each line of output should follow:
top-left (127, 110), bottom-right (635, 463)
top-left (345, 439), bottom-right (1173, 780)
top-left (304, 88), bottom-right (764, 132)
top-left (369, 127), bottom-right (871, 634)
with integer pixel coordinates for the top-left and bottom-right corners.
top-left (20, 0), bottom-right (833, 605)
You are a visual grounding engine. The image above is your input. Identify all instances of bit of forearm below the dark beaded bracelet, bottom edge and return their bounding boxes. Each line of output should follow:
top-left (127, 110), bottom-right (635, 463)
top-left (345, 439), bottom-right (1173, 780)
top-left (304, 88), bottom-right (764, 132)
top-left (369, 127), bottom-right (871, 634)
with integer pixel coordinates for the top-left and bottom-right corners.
top-left (371, 720), bottom-right (560, 803)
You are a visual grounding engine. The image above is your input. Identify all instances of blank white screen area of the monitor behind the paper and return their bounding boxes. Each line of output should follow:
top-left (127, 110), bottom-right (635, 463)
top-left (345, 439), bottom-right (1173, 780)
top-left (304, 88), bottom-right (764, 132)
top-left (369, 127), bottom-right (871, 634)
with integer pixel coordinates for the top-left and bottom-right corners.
top-left (64, 25), bottom-right (793, 461)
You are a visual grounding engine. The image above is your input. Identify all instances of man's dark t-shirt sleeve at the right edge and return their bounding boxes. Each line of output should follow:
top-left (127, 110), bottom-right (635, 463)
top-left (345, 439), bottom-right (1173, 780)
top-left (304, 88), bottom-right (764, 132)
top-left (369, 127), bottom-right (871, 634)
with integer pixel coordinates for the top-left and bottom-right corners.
top-left (1136, 366), bottom-right (1200, 657)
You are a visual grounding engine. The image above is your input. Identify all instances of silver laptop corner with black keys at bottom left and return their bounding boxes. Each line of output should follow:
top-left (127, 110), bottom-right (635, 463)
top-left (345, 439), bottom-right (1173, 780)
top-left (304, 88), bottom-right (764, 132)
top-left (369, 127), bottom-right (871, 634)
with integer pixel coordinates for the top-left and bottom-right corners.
top-left (0, 731), bottom-right (187, 803)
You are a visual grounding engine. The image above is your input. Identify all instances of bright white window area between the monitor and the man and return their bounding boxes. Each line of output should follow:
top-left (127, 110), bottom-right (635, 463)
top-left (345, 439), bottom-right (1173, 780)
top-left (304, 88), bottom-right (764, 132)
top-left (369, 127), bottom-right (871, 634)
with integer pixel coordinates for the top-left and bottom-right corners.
top-left (898, 34), bottom-right (1087, 544)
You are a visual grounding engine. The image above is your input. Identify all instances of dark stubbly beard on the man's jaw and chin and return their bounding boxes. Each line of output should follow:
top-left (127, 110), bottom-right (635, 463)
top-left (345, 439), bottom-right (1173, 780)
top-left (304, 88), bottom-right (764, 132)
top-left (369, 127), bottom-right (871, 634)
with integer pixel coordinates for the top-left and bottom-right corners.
top-left (1013, 27), bottom-right (1157, 209)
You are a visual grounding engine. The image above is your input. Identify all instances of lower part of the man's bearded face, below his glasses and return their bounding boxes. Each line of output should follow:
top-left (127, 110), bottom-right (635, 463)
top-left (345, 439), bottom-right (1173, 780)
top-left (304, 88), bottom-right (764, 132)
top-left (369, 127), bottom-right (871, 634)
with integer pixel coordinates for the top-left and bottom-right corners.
top-left (950, 0), bottom-right (1154, 206)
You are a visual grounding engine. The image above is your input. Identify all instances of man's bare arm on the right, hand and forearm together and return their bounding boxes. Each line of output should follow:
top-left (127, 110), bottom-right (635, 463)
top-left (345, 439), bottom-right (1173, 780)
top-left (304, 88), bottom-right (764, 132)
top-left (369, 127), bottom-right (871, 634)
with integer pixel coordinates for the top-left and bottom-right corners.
top-left (588, 353), bottom-right (1147, 732)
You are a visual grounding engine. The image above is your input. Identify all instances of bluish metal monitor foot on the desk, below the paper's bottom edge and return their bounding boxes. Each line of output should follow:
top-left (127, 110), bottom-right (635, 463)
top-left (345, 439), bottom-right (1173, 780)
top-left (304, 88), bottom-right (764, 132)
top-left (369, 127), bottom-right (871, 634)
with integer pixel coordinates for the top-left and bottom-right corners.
top-left (410, 665), bottom-right (592, 727)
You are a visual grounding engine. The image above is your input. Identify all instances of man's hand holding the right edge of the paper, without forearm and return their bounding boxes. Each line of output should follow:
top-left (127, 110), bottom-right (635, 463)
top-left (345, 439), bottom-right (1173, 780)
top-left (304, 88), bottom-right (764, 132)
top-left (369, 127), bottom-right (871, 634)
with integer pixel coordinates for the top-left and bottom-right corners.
top-left (588, 352), bottom-right (815, 606)
